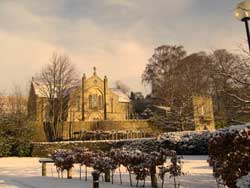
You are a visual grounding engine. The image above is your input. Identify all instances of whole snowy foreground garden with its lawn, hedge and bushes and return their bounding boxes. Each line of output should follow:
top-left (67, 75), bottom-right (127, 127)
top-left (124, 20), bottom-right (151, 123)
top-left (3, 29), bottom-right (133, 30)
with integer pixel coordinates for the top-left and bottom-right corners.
top-left (0, 125), bottom-right (250, 188)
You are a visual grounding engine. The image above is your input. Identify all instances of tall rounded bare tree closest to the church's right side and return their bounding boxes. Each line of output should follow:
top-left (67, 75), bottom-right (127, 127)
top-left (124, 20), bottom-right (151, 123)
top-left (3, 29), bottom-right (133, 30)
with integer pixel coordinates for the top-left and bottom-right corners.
top-left (142, 45), bottom-right (186, 102)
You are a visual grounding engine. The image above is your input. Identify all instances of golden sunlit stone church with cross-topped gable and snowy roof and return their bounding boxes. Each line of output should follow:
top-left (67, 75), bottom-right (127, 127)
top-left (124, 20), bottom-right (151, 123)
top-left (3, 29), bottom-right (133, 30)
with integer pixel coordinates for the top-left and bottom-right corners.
top-left (28, 67), bottom-right (132, 122)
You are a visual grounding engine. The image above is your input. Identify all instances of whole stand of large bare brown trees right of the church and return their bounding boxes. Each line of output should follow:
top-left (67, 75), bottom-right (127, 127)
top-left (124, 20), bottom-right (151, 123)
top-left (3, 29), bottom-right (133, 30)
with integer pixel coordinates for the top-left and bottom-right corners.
top-left (142, 46), bottom-right (250, 126)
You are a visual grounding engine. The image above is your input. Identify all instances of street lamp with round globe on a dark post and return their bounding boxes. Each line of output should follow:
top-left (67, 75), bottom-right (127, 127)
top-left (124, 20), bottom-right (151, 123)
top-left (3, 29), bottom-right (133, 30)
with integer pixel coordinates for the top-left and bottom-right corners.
top-left (234, 0), bottom-right (250, 52)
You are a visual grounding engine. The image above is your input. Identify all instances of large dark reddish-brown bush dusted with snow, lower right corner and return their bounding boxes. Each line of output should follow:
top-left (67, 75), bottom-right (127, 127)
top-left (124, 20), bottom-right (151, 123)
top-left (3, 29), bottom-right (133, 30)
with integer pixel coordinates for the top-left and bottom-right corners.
top-left (208, 125), bottom-right (250, 188)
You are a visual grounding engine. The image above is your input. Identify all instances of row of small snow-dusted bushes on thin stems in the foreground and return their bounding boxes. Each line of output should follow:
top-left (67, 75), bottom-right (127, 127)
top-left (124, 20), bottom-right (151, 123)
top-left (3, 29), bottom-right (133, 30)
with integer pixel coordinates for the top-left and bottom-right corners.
top-left (48, 148), bottom-right (184, 187)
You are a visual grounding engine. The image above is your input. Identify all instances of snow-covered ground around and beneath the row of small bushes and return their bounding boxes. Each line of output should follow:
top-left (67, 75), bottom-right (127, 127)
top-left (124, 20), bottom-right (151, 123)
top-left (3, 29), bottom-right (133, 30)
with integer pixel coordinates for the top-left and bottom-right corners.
top-left (0, 156), bottom-right (223, 188)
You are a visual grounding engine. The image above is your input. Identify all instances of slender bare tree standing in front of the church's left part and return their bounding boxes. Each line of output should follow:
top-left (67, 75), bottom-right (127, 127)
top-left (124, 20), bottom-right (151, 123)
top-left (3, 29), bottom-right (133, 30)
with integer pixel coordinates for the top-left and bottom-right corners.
top-left (37, 53), bottom-right (78, 140)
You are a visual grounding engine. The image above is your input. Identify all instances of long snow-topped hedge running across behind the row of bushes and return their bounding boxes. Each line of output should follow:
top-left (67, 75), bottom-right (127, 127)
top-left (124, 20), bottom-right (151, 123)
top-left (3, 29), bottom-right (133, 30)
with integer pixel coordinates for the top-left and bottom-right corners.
top-left (31, 131), bottom-right (212, 157)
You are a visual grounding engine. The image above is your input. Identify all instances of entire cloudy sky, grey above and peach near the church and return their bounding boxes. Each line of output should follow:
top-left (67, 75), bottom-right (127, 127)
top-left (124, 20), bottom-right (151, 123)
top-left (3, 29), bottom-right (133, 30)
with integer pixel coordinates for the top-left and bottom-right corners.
top-left (0, 0), bottom-right (245, 92)
